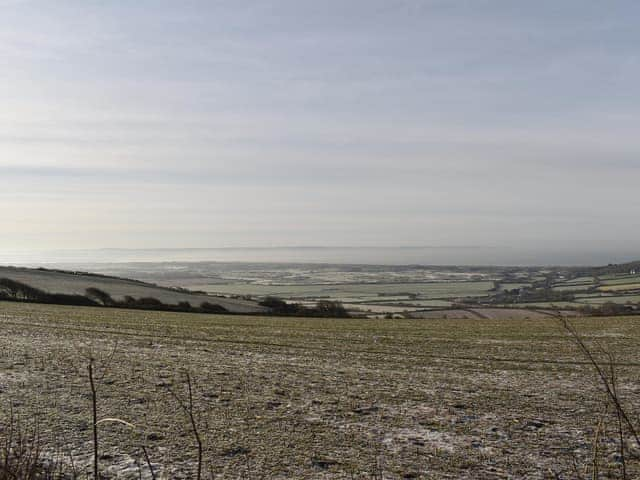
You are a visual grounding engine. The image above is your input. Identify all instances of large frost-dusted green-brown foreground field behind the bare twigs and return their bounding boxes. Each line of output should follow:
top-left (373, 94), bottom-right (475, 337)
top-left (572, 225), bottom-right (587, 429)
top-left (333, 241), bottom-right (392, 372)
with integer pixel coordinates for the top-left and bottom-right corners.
top-left (0, 303), bottom-right (640, 479)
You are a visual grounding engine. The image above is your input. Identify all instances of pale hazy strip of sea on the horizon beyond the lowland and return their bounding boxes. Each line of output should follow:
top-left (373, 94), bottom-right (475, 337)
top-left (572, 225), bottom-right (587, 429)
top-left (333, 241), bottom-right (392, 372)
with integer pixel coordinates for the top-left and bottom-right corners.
top-left (0, 245), bottom-right (640, 266)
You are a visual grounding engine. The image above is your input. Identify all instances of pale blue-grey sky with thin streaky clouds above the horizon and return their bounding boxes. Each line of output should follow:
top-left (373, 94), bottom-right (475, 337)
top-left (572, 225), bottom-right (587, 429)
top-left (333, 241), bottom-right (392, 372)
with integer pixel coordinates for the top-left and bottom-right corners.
top-left (0, 0), bottom-right (640, 257)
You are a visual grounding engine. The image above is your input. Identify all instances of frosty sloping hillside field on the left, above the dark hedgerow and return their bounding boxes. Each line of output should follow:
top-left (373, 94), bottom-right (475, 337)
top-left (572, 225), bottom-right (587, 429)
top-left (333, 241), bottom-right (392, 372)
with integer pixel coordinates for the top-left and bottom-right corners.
top-left (0, 267), bottom-right (267, 313)
